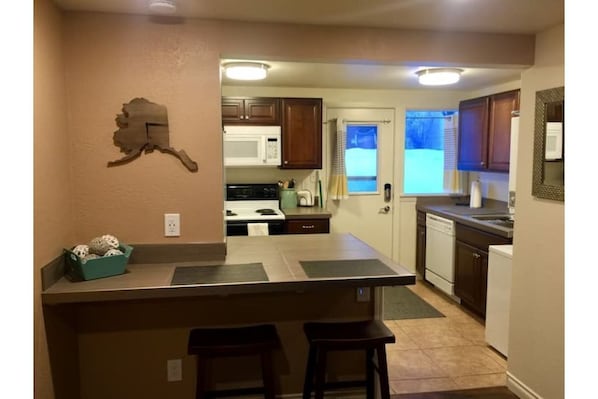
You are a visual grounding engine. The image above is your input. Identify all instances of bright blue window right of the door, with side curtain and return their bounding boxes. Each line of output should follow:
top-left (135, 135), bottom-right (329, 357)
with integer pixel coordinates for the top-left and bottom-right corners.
top-left (403, 110), bottom-right (457, 194)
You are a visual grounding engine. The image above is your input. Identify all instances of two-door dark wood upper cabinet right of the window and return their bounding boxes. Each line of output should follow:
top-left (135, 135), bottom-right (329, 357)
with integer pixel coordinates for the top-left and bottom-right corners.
top-left (458, 90), bottom-right (520, 172)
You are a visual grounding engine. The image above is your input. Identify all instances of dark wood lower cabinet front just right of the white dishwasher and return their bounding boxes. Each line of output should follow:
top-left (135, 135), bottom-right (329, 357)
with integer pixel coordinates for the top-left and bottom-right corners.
top-left (455, 241), bottom-right (488, 316)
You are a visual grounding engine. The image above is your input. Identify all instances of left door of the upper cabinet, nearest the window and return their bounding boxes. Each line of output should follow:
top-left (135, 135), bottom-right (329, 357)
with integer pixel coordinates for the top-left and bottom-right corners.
top-left (457, 97), bottom-right (489, 170)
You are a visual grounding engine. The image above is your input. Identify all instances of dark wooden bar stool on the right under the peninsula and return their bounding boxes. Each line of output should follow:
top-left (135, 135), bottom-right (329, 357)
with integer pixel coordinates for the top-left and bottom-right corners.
top-left (303, 320), bottom-right (395, 399)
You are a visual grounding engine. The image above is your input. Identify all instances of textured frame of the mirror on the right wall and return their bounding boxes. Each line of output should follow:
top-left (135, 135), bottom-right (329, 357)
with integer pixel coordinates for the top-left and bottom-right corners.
top-left (532, 86), bottom-right (565, 201)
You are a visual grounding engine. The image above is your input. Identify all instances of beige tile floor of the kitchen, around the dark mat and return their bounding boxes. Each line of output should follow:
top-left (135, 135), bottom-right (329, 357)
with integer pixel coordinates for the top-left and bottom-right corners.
top-left (385, 280), bottom-right (507, 394)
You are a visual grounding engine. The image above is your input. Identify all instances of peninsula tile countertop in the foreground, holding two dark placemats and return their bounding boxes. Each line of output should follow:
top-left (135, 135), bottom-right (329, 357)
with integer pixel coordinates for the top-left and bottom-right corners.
top-left (42, 234), bottom-right (415, 305)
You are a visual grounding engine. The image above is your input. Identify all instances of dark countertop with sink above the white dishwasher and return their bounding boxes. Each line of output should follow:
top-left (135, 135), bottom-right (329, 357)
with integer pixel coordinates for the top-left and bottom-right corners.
top-left (416, 198), bottom-right (513, 238)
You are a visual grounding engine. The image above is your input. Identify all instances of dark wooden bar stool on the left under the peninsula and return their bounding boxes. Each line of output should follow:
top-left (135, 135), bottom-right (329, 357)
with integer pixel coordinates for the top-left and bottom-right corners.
top-left (187, 324), bottom-right (280, 399)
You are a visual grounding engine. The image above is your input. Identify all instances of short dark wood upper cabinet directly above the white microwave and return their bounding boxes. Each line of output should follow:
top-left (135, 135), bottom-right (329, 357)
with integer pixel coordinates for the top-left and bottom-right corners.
top-left (222, 97), bottom-right (280, 125)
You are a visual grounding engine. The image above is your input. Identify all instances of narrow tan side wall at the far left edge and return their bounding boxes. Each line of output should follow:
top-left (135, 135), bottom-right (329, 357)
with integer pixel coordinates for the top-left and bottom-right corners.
top-left (33, 0), bottom-right (74, 398)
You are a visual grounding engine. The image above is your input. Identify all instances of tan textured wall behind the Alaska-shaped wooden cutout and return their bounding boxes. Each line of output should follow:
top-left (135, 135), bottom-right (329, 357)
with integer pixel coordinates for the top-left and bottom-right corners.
top-left (65, 13), bottom-right (223, 243)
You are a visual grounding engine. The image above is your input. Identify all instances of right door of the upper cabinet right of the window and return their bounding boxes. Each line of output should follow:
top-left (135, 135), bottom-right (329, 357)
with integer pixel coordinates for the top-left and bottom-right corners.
top-left (488, 90), bottom-right (519, 172)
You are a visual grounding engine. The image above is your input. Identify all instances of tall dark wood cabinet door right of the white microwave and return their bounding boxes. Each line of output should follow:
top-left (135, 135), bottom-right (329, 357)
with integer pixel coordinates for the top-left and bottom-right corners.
top-left (281, 98), bottom-right (322, 169)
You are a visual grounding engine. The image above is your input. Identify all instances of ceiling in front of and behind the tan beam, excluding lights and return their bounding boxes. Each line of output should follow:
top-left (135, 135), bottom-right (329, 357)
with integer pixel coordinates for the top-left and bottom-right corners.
top-left (54, 0), bottom-right (564, 90)
